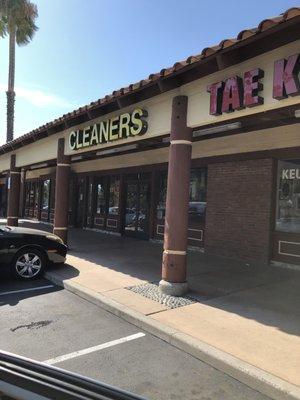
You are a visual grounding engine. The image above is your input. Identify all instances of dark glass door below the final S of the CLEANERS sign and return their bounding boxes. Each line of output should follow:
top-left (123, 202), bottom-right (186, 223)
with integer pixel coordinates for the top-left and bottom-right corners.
top-left (124, 174), bottom-right (150, 239)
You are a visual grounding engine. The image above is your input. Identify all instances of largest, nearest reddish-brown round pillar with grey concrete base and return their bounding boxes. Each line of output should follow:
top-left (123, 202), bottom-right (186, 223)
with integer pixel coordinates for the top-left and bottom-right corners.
top-left (159, 96), bottom-right (192, 296)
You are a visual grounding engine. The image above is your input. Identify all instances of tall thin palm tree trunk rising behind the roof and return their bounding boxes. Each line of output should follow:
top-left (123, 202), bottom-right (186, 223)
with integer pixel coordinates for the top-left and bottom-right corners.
top-left (6, 29), bottom-right (16, 142)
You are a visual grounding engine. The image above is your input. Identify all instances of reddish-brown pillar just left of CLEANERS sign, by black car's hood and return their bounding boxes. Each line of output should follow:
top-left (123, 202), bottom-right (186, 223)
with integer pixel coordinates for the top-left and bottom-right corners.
top-left (53, 138), bottom-right (70, 243)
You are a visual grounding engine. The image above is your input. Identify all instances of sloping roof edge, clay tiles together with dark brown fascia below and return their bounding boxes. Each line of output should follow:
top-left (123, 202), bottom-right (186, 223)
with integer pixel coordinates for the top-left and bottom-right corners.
top-left (0, 7), bottom-right (300, 154)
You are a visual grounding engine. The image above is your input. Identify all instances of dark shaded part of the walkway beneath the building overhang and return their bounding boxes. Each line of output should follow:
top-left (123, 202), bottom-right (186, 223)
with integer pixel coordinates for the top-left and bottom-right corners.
top-left (16, 220), bottom-right (300, 336)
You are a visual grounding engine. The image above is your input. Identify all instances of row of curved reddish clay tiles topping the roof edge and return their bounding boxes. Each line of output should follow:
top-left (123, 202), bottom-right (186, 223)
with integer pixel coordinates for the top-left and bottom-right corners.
top-left (0, 7), bottom-right (300, 153)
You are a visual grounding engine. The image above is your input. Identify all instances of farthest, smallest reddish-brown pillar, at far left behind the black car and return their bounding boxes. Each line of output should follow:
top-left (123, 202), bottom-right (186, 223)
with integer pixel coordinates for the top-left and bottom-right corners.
top-left (7, 154), bottom-right (21, 226)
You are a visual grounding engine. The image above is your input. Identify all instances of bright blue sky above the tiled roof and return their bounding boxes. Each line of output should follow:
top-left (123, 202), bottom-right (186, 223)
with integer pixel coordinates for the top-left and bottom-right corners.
top-left (0, 0), bottom-right (300, 144)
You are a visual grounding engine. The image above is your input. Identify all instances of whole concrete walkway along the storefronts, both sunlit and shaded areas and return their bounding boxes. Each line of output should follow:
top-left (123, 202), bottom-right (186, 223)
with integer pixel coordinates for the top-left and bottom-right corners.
top-left (14, 220), bottom-right (300, 399)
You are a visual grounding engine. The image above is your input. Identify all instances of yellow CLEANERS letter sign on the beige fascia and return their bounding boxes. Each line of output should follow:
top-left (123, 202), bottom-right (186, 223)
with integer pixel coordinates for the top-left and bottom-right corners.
top-left (69, 108), bottom-right (148, 150)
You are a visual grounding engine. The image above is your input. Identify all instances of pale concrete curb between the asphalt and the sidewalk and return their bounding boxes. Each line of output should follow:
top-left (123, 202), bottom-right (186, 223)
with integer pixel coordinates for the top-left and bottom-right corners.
top-left (45, 272), bottom-right (300, 400)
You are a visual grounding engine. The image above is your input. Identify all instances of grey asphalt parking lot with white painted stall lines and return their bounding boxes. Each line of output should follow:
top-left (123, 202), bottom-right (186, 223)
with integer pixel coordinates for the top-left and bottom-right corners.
top-left (0, 275), bottom-right (268, 400)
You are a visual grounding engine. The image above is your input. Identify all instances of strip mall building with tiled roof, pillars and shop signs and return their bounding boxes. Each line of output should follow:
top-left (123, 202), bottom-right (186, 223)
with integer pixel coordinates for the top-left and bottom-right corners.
top-left (0, 8), bottom-right (300, 294)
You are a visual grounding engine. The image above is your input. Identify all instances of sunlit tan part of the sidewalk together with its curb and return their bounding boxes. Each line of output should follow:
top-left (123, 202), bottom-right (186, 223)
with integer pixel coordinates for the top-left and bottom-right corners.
top-left (46, 255), bottom-right (300, 400)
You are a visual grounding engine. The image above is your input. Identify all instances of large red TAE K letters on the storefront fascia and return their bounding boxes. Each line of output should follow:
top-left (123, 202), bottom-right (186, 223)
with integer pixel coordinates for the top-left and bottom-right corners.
top-left (207, 54), bottom-right (300, 115)
